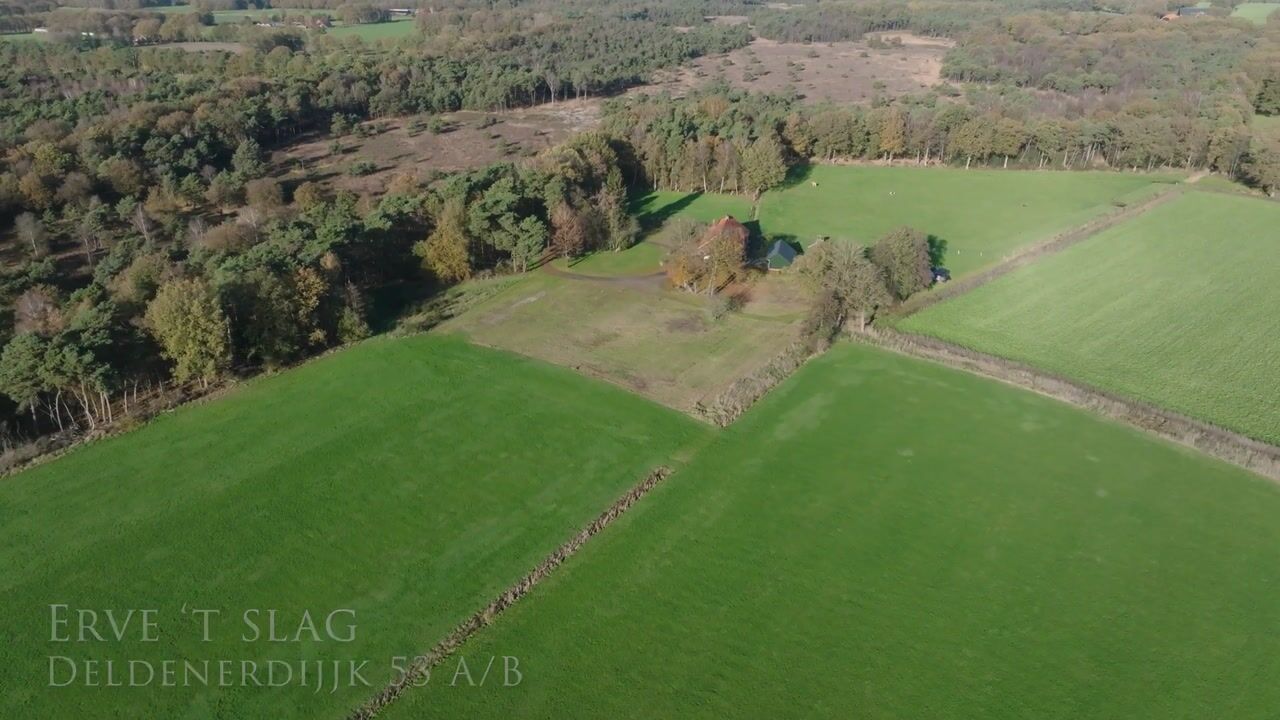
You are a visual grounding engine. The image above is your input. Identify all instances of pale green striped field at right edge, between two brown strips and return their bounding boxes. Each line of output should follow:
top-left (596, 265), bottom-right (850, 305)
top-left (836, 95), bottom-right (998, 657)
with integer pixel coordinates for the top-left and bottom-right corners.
top-left (901, 192), bottom-right (1280, 443)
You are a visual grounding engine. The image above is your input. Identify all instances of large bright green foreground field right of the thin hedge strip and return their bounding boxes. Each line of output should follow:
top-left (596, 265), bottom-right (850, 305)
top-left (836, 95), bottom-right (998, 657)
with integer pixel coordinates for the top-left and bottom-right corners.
top-left (387, 345), bottom-right (1280, 720)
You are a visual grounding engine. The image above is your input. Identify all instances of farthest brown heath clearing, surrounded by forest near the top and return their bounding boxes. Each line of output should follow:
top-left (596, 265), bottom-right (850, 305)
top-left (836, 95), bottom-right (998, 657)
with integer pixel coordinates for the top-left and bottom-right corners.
top-left (631, 32), bottom-right (948, 102)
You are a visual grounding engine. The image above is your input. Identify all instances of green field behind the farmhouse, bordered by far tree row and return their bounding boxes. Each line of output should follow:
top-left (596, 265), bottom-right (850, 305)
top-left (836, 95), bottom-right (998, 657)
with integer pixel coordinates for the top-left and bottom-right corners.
top-left (759, 165), bottom-right (1170, 275)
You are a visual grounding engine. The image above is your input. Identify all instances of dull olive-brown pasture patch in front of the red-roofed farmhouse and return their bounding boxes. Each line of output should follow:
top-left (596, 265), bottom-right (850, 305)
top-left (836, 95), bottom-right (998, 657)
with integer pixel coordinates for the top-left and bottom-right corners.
top-left (443, 270), bottom-right (805, 411)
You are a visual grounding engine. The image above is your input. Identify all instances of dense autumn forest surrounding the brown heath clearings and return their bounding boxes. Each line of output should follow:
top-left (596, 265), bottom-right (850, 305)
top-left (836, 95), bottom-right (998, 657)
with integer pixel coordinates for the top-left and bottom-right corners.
top-left (0, 0), bottom-right (1280, 450)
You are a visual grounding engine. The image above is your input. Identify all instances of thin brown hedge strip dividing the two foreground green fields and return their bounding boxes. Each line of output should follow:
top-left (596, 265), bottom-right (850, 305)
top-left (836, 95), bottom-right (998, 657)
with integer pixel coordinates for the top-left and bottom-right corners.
top-left (347, 465), bottom-right (672, 720)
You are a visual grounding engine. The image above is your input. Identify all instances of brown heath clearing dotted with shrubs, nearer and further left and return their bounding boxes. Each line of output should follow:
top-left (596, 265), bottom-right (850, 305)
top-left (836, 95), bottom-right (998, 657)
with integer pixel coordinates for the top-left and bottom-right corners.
top-left (271, 101), bottom-right (599, 196)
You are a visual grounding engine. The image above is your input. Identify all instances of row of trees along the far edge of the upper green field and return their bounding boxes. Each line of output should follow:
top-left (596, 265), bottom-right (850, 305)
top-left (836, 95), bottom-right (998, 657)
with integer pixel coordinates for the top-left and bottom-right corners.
top-left (604, 86), bottom-right (1280, 193)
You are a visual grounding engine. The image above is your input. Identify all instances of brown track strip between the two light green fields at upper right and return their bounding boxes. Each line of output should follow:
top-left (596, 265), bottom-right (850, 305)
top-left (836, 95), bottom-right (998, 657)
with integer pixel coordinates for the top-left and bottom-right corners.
top-left (890, 183), bottom-right (1183, 319)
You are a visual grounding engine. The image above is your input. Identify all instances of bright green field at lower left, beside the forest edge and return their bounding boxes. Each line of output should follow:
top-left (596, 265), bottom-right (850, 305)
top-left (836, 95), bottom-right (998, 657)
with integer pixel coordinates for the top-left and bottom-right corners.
top-left (0, 337), bottom-right (707, 719)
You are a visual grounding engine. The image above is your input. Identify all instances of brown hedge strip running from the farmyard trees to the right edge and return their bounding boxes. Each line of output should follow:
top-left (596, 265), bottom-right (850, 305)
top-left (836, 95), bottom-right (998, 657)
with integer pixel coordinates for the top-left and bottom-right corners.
top-left (854, 328), bottom-right (1280, 483)
